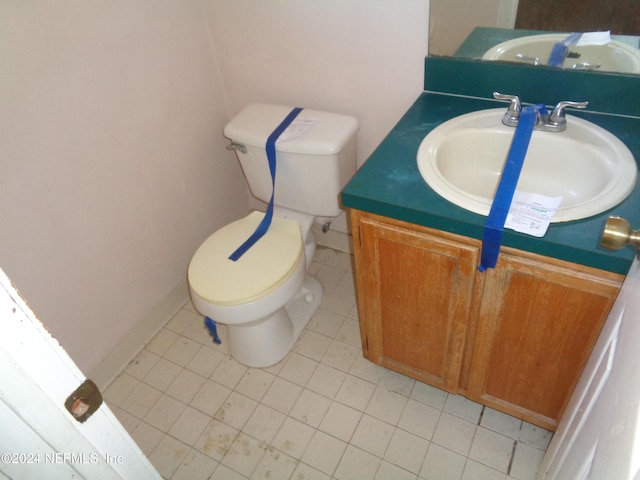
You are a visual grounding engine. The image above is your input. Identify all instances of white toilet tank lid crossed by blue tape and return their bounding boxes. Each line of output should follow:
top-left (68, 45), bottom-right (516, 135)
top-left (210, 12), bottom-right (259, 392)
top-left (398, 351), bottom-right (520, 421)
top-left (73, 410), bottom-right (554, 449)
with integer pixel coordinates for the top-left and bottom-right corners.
top-left (224, 103), bottom-right (359, 155)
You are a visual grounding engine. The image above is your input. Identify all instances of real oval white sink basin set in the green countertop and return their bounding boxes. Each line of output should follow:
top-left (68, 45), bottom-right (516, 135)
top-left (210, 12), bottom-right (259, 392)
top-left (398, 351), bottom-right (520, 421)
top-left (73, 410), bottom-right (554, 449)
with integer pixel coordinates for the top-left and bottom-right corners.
top-left (417, 108), bottom-right (638, 222)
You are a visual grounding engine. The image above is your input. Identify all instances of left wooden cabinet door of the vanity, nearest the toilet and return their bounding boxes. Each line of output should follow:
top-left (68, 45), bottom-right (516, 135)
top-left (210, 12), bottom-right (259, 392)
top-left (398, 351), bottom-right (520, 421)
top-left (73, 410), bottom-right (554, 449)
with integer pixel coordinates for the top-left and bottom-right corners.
top-left (352, 211), bottom-right (480, 391)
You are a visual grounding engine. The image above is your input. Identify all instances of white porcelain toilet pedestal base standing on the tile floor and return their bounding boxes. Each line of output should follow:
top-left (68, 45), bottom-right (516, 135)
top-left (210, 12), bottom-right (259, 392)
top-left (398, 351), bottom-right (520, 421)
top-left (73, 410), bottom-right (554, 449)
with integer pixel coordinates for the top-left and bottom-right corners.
top-left (227, 276), bottom-right (323, 368)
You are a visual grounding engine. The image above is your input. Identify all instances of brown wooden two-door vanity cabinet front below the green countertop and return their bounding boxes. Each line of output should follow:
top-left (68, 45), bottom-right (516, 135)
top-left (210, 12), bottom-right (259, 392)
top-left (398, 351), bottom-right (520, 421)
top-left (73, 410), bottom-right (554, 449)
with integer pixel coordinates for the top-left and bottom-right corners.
top-left (351, 210), bottom-right (623, 430)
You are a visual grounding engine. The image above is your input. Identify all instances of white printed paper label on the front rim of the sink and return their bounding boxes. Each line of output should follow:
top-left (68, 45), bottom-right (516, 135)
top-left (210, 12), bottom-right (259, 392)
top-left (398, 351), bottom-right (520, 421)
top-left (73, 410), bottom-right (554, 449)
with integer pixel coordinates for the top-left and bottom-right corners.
top-left (504, 190), bottom-right (562, 237)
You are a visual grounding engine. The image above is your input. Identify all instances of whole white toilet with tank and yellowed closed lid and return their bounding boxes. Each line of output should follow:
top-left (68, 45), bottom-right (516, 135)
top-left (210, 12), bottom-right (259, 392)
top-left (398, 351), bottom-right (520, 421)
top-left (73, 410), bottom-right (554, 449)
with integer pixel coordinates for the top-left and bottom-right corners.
top-left (188, 103), bottom-right (359, 367)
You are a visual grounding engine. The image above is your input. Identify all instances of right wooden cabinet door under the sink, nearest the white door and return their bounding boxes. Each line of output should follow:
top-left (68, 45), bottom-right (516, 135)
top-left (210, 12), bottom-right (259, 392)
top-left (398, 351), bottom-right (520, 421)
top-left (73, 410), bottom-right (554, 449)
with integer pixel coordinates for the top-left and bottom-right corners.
top-left (467, 249), bottom-right (621, 430)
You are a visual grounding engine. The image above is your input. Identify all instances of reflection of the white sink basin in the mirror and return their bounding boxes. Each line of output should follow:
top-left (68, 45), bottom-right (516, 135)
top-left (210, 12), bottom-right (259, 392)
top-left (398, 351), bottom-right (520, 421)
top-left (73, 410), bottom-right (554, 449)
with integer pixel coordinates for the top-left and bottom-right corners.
top-left (482, 33), bottom-right (640, 73)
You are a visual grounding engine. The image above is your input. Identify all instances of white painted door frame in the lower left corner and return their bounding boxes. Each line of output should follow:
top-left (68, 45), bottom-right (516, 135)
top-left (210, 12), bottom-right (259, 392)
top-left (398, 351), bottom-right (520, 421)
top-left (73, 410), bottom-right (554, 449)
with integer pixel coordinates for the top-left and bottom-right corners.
top-left (0, 269), bottom-right (160, 480)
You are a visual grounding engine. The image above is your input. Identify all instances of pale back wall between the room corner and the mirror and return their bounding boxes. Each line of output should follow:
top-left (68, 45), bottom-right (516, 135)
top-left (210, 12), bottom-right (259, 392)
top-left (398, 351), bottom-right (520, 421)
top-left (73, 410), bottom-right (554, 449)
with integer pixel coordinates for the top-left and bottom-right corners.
top-left (204, 0), bottom-right (429, 169)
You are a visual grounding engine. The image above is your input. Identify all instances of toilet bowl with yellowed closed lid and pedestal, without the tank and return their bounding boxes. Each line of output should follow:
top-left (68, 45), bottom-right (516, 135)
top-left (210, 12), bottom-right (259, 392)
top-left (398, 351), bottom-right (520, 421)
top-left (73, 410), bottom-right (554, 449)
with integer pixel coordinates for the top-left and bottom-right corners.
top-left (188, 209), bottom-right (322, 367)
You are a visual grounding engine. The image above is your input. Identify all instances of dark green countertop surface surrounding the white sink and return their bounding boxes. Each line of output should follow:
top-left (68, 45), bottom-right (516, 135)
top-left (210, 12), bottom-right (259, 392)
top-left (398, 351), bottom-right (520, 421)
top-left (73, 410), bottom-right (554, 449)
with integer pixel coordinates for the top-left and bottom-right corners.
top-left (342, 92), bottom-right (640, 274)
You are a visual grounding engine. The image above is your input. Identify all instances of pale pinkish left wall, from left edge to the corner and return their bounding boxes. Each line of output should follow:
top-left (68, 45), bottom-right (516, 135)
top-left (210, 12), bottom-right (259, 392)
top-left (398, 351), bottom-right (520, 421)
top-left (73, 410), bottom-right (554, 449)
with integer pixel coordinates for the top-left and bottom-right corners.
top-left (0, 0), bottom-right (248, 372)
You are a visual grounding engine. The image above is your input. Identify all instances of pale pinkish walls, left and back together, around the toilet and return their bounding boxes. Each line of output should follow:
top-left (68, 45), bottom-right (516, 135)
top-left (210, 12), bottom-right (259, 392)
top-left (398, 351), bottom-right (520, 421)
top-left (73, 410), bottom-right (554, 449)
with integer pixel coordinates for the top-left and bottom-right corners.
top-left (0, 0), bottom-right (429, 380)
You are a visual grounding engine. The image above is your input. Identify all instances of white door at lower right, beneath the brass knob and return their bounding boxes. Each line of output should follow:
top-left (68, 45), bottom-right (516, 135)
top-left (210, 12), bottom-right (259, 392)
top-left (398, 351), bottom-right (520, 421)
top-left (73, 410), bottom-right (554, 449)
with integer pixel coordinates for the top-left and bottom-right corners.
top-left (538, 259), bottom-right (640, 480)
